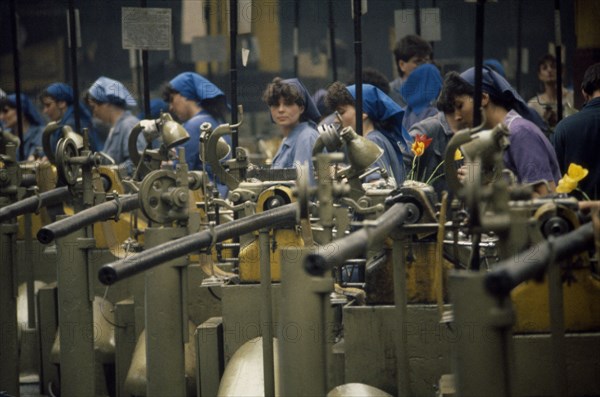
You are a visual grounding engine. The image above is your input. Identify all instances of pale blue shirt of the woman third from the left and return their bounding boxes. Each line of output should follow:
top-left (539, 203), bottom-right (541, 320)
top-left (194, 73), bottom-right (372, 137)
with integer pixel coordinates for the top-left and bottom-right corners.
top-left (103, 110), bottom-right (145, 174)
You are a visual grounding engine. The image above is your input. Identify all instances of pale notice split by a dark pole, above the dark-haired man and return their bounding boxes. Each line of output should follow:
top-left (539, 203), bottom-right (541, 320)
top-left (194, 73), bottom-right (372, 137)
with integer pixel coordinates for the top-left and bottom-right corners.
top-left (394, 8), bottom-right (442, 41)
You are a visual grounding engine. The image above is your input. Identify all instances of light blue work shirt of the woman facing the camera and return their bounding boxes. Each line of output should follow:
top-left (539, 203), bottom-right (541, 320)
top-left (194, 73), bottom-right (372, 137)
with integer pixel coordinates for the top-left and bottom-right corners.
top-left (271, 121), bottom-right (319, 185)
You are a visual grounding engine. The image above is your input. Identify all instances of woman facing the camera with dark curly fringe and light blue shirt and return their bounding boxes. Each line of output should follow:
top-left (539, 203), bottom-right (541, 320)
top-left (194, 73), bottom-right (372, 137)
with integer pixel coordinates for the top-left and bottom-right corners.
top-left (263, 77), bottom-right (321, 184)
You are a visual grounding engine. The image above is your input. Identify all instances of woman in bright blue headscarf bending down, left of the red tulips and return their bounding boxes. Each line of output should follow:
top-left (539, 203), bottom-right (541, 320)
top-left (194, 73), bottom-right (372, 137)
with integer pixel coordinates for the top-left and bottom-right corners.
top-left (326, 82), bottom-right (408, 186)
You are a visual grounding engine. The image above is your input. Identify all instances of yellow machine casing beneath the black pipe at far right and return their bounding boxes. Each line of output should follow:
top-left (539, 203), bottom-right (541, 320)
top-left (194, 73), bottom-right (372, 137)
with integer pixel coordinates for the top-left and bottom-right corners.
top-left (511, 268), bottom-right (600, 333)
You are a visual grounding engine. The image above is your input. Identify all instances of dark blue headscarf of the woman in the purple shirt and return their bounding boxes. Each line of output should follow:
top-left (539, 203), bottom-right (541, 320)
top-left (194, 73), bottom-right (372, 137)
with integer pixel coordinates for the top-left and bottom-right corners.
top-left (460, 66), bottom-right (546, 131)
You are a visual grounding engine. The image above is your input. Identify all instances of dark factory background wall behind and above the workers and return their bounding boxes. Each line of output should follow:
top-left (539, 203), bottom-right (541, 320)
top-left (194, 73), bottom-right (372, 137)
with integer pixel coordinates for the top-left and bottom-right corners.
top-left (0, 0), bottom-right (580, 116)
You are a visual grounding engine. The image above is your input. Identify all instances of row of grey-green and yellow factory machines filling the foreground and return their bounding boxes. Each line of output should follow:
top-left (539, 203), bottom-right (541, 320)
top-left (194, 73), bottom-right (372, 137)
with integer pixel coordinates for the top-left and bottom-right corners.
top-left (0, 108), bottom-right (600, 396)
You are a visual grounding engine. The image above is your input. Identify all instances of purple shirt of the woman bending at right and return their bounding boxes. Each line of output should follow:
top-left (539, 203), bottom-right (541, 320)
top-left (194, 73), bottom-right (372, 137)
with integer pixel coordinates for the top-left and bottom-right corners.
top-left (504, 110), bottom-right (560, 184)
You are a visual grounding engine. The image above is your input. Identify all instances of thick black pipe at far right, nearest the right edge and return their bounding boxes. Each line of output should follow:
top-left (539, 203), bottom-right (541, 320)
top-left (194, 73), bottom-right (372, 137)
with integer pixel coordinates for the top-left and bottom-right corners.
top-left (485, 222), bottom-right (594, 296)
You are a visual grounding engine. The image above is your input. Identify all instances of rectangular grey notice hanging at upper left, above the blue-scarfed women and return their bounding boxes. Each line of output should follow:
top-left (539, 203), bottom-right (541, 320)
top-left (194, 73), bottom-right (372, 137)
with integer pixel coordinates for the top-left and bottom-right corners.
top-left (121, 7), bottom-right (173, 50)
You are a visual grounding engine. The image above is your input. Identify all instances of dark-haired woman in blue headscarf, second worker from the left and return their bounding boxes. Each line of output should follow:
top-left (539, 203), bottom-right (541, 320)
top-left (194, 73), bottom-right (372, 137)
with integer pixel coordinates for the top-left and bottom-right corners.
top-left (39, 83), bottom-right (104, 152)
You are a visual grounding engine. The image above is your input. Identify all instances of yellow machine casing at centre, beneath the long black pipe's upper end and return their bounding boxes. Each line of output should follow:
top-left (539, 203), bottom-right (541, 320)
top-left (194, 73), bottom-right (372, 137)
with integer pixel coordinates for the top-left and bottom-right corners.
top-left (239, 229), bottom-right (304, 283)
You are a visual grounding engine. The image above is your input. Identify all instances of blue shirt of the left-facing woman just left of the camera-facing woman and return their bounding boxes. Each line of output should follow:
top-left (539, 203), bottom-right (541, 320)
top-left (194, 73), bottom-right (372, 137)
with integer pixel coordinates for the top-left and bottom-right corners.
top-left (182, 110), bottom-right (231, 197)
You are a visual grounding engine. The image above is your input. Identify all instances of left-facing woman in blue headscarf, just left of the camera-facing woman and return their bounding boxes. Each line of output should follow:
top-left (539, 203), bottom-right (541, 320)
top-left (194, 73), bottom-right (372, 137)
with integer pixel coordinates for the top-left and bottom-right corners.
top-left (163, 72), bottom-right (231, 197)
